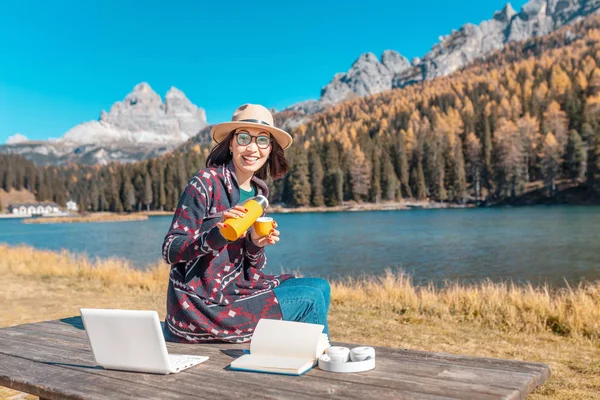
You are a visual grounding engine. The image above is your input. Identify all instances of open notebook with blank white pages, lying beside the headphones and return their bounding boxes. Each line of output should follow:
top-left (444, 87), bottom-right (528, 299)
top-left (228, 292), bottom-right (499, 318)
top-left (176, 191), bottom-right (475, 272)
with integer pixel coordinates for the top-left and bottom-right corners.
top-left (230, 319), bottom-right (329, 375)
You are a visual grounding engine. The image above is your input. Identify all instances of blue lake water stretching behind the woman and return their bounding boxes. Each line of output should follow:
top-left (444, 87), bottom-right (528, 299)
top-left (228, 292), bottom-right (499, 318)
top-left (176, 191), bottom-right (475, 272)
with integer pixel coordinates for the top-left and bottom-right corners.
top-left (0, 206), bottom-right (600, 286)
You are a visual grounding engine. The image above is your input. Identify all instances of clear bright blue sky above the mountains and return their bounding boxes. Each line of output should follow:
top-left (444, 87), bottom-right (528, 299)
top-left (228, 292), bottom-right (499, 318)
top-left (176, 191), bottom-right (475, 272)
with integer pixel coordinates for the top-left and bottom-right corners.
top-left (0, 0), bottom-right (525, 143)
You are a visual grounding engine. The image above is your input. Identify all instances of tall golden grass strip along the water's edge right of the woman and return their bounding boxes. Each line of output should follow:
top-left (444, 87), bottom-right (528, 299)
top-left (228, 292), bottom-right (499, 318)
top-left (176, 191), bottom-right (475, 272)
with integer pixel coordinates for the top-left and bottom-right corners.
top-left (332, 271), bottom-right (600, 341)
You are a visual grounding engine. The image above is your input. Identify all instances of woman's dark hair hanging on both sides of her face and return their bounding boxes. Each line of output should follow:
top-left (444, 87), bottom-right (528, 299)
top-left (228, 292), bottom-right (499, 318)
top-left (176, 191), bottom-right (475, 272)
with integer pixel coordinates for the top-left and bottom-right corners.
top-left (206, 130), bottom-right (290, 180)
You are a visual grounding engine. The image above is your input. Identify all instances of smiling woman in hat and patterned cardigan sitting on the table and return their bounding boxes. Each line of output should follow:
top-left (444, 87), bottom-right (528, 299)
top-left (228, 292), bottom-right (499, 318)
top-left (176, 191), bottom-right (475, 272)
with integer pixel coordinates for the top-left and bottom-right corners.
top-left (163, 104), bottom-right (329, 343)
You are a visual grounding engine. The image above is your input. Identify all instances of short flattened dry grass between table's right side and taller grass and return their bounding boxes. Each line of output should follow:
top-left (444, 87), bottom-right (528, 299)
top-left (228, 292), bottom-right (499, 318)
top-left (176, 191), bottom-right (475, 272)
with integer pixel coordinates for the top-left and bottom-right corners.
top-left (329, 303), bottom-right (600, 400)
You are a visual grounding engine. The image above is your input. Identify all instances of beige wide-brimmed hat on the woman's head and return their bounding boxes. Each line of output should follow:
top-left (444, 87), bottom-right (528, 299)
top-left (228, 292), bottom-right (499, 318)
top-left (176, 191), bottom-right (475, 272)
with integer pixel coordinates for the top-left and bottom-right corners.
top-left (210, 104), bottom-right (292, 150)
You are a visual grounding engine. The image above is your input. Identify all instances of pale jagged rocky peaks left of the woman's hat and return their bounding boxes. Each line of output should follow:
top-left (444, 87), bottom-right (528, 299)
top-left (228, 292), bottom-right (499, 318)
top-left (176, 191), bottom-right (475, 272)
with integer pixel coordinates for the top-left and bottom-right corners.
top-left (0, 82), bottom-right (207, 165)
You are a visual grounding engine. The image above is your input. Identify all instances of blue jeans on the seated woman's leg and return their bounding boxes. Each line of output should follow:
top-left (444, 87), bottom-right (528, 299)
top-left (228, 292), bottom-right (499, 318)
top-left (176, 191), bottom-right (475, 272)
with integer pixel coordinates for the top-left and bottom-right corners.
top-left (273, 278), bottom-right (331, 335)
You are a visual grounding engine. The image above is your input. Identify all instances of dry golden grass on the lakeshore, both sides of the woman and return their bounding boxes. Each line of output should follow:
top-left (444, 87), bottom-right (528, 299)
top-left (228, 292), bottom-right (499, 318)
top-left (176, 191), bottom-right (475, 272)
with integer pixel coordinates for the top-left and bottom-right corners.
top-left (0, 245), bottom-right (600, 399)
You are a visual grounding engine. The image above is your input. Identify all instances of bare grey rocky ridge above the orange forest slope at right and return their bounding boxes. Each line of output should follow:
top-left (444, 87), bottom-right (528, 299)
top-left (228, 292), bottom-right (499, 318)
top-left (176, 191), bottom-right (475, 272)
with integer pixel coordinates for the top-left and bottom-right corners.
top-left (291, 0), bottom-right (600, 113)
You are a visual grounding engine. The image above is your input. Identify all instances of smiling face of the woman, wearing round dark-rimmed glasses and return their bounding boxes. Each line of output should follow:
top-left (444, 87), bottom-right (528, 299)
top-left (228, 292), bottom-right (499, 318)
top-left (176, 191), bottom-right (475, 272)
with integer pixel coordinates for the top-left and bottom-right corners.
top-left (229, 127), bottom-right (272, 179)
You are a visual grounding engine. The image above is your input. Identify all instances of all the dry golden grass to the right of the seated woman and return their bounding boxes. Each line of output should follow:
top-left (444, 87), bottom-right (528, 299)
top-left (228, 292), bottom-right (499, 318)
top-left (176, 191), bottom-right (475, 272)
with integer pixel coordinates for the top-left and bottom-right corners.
top-left (329, 272), bottom-right (600, 400)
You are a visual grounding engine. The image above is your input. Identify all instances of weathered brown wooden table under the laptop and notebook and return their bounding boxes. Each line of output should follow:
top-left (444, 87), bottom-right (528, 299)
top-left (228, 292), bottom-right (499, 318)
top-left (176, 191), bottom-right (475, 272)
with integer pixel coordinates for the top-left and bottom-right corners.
top-left (0, 317), bottom-right (550, 400)
